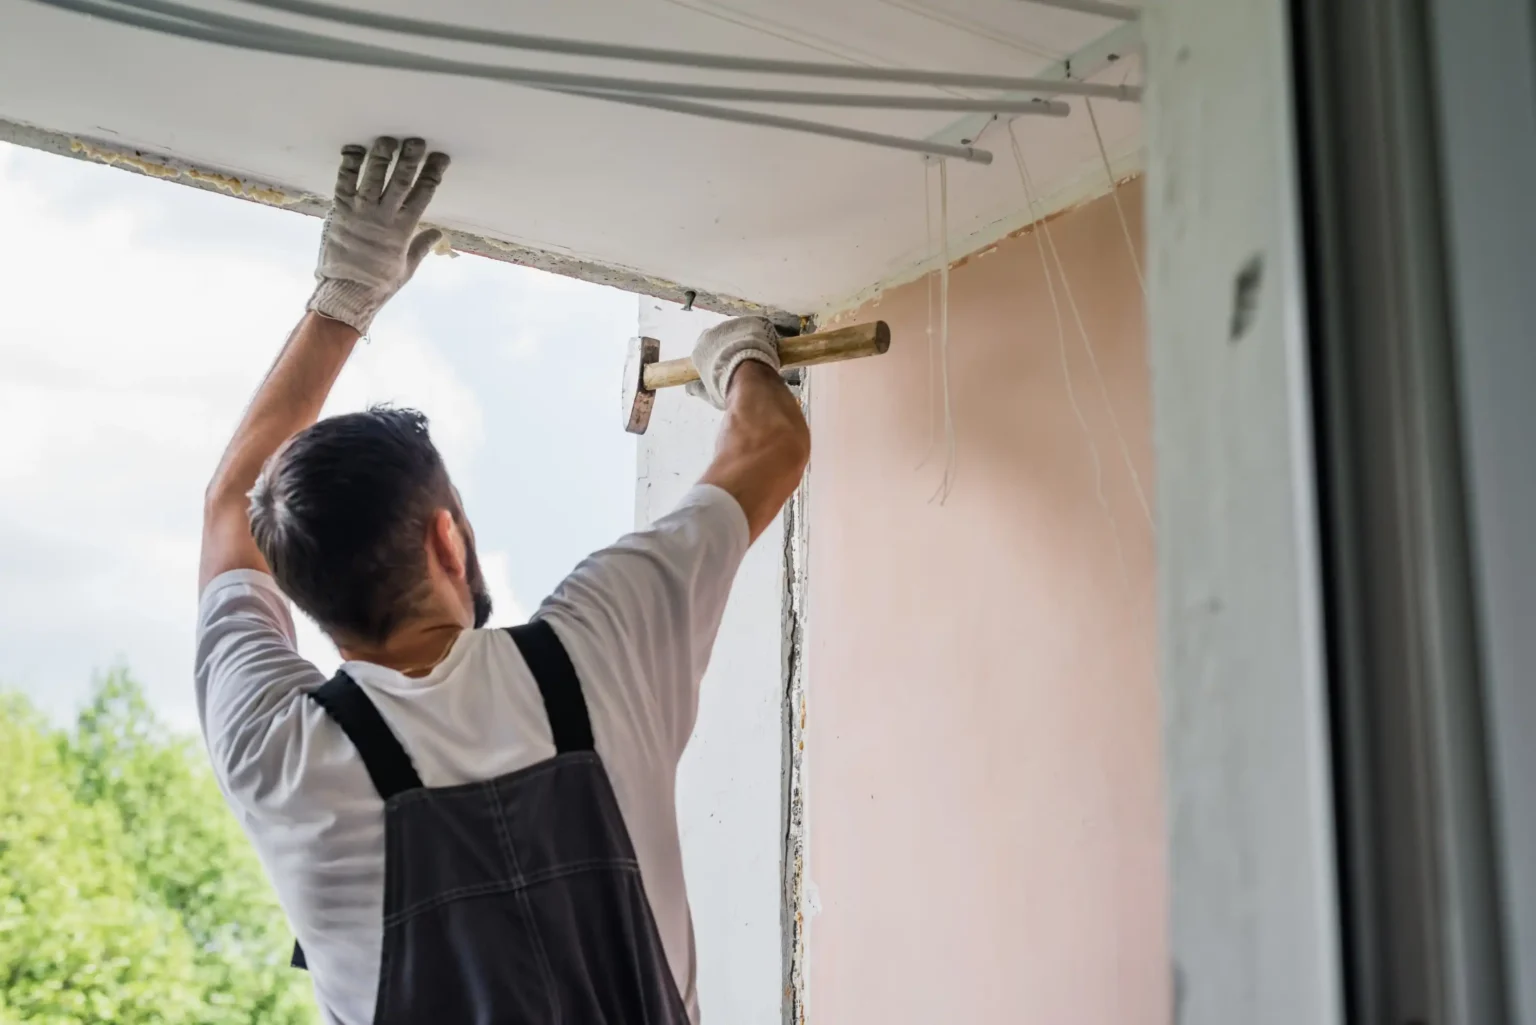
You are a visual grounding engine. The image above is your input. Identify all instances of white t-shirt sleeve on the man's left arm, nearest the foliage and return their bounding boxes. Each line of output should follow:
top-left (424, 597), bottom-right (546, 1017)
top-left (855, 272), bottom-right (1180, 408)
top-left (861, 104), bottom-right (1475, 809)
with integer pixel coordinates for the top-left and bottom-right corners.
top-left (195, 570), bottom-right (324, 805)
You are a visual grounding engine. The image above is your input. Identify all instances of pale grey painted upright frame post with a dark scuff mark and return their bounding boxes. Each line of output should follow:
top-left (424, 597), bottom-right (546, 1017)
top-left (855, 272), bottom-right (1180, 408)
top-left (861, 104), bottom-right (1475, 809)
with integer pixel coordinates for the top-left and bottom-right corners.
top-left (1143, 0), bottom-right (1342, 1025)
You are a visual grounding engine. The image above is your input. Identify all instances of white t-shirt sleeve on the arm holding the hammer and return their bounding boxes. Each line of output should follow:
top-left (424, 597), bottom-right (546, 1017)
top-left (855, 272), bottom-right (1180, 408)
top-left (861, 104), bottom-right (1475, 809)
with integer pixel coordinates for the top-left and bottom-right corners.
top-left (535, 484), bottom-right (751, 759)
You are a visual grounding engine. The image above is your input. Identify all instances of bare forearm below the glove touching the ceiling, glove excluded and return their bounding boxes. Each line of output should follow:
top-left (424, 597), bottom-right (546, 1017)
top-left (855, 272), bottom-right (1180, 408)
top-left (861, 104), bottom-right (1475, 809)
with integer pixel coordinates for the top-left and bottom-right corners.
top-left (209, 313), bottom-right (358, 504)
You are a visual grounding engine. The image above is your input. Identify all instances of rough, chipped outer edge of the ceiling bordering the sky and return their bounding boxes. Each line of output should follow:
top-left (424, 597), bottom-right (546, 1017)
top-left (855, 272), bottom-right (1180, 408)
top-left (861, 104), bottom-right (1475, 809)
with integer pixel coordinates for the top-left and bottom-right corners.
top-left (0, 118), bottom-right (806, 332)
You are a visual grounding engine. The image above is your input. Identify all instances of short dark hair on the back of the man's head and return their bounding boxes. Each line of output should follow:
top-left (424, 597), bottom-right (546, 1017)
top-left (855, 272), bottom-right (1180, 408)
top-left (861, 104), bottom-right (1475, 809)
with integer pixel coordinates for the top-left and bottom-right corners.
top-left (250, 406), bottom-right (459, 644)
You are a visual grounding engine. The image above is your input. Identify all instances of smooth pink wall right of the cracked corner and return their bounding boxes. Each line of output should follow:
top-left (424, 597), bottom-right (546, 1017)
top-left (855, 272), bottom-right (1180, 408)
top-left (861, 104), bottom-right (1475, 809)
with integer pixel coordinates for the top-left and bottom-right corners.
top-left (806, 183), bottom-right (1169, 1025)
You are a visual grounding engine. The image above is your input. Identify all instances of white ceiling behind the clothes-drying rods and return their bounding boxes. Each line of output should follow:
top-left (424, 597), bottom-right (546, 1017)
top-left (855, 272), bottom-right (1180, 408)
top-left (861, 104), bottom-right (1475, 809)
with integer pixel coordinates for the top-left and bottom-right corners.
top-left (0, 0), bottom-right (1140, 313)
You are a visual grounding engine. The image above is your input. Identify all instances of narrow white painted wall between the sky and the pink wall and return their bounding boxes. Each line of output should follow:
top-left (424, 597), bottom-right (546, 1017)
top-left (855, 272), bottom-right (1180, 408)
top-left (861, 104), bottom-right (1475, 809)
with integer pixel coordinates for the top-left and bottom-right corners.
top-left (632, 297), bottom-right (783, 1025)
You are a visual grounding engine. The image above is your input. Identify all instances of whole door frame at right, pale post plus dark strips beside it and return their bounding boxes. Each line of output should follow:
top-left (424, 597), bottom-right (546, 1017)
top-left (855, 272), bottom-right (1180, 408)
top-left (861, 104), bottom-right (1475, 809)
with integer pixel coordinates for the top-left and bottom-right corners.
top-left (1146, 0), bottom-right (1536, 1025)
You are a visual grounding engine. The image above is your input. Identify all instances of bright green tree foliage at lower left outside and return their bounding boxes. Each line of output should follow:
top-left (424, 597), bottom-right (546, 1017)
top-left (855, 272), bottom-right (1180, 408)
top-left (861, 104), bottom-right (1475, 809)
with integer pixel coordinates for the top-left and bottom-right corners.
top-left (0, 672), bottom-right (315, 1025)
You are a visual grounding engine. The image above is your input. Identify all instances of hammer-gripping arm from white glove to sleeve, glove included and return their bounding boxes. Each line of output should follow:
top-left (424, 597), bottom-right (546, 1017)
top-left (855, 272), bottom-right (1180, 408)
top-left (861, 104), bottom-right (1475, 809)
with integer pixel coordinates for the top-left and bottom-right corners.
top-left (690, 317), bottom-right (811, 541)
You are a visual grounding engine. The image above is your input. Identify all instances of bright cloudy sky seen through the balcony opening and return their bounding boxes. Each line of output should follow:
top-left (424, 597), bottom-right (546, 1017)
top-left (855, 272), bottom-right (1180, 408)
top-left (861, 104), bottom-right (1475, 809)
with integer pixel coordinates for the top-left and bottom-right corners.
top-left (0, 143), bottom-right (637, 730)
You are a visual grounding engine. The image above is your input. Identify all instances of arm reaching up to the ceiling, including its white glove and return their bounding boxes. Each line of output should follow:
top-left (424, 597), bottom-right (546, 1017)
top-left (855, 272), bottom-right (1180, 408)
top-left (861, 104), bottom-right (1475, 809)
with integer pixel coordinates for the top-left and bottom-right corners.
top-left (198, 138), bottom-right (449, 590)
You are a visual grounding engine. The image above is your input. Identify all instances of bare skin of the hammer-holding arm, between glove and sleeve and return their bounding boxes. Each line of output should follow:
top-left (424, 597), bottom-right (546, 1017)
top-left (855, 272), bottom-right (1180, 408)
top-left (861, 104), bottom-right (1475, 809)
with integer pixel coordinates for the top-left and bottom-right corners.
top-left (702, 361), bottom-right (811, 539)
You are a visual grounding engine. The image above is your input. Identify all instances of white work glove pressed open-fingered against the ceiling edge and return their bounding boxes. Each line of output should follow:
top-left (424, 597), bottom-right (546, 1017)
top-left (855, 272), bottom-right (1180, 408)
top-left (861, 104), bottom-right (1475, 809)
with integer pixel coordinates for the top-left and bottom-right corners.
top-left (309, 137), bottom-right (449, 333)
